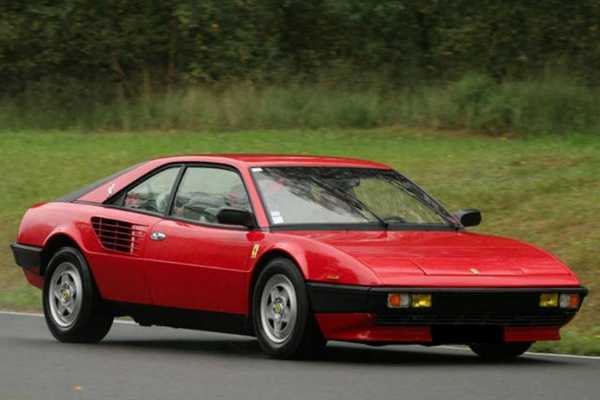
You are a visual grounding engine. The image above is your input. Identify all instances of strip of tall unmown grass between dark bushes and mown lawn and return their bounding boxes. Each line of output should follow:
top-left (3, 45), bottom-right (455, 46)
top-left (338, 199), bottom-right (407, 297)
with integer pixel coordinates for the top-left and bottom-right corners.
top-left (0, 74), bottom-right (600, 135)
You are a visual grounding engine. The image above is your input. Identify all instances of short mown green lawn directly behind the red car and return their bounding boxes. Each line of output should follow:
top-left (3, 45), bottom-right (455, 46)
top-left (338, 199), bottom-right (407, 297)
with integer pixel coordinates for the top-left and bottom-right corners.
top-left (0, 128), bottom-right (600, 354)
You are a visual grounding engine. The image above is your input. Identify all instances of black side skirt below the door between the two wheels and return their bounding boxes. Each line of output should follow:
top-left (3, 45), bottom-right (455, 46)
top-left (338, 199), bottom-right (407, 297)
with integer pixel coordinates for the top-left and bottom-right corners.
top-left (107, 301), bottom-right (254, 336)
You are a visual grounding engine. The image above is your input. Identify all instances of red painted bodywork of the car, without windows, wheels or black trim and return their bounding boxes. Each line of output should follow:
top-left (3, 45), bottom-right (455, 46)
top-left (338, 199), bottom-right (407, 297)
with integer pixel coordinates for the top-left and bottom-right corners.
top-left (17, 155), bottom-right (580, 343)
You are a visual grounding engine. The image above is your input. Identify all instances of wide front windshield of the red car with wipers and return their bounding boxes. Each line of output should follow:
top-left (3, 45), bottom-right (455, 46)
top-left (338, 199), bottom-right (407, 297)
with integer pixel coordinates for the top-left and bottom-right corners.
top-left (252, 167), bottom-right (456, 227)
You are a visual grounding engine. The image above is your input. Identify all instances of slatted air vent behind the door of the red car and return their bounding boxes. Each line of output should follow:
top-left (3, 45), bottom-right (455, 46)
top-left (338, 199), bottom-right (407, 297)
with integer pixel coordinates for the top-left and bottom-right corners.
top-left (92, 217), bottom-right (144, 254)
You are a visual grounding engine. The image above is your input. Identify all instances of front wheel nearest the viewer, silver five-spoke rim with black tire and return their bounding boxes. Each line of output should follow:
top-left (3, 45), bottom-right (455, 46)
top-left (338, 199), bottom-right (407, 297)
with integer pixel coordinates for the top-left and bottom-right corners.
top-left (252, 258), bottom-right (326, 358)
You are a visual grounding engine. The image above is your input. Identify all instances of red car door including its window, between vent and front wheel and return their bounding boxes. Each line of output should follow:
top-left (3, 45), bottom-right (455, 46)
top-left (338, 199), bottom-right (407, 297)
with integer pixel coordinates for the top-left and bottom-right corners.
top-left (146, 165), bottom-right (253, 314)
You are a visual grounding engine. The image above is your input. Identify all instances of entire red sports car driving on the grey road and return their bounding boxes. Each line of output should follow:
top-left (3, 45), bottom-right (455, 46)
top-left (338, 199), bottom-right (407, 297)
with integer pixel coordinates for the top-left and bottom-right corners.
top-left (12, 155), bottom-right (587, 359)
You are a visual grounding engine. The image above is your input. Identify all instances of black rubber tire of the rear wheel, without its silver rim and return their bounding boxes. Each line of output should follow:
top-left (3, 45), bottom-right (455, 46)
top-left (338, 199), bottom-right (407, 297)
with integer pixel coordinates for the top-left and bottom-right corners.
top-left (42, 247), bottom-right (114, 343)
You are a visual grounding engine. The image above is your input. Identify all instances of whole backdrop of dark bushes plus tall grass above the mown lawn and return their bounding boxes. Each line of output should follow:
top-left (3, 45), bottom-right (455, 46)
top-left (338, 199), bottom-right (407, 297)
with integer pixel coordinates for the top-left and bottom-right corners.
top-left (0, 0), bottom-right (600, 133)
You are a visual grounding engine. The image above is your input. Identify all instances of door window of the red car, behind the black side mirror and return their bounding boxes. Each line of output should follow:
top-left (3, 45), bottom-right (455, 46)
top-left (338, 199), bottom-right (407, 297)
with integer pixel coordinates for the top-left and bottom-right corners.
top-left (171, 167), bottom-right (250, 223)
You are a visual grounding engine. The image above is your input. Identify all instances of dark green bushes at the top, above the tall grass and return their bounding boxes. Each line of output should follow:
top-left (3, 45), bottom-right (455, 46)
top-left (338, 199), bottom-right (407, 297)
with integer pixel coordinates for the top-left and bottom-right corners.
top-left (0, 0), bottom-right (600, 90)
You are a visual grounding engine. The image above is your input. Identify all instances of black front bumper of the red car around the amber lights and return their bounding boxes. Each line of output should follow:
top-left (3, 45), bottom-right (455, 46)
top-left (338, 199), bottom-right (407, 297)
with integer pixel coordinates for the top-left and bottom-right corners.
top-left (308, 282), bottom-right (587, 326)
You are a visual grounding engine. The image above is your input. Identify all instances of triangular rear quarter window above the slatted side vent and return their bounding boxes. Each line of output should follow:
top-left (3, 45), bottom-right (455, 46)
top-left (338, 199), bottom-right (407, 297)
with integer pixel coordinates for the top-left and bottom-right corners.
top-left (113, 167), bottom-right (179, 214)
